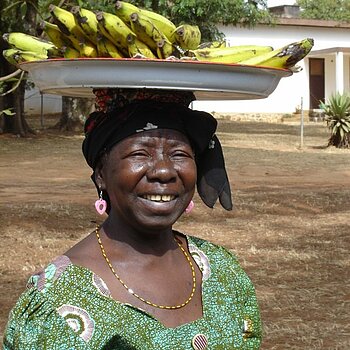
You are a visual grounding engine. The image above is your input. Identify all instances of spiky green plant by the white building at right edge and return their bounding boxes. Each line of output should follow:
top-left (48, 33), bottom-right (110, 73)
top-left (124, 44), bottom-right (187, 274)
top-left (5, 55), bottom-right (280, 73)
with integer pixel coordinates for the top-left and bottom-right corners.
top-left (320, 93), bottom-right (350, 148)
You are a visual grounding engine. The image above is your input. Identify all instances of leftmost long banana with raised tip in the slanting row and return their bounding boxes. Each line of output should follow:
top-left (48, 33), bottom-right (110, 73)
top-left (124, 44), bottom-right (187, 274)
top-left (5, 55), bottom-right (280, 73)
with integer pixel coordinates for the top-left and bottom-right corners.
top-left (49, 4), bottom-right (97, 57)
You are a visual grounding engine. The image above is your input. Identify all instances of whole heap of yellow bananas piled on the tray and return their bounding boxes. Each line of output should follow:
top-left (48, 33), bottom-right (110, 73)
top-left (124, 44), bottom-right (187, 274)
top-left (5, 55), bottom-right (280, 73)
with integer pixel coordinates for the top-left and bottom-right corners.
top-left (3, 1), bottom-right (314, 69)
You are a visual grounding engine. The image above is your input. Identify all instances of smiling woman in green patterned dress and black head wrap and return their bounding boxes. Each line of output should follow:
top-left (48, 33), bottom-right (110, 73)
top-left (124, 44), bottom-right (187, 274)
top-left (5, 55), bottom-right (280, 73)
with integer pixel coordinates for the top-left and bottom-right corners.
top-left (4, 89), bottom-right (261, 350)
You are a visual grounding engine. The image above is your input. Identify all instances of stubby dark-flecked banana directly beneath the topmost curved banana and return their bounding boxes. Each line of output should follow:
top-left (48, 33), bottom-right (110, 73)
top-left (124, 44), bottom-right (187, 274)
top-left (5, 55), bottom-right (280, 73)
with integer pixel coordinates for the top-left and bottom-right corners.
top-left (130, 13), bottom-right (166, 52)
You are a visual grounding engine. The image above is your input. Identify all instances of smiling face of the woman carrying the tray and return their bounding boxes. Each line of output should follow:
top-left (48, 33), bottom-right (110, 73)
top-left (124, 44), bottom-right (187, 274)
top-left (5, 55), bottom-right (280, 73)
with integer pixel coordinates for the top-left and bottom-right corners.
top-left (99, 129), bottom-right (197, 231)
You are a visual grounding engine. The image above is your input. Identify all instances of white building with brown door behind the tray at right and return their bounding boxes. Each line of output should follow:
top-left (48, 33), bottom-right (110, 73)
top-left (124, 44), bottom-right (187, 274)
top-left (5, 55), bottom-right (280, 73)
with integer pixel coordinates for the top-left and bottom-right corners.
top-left (194, 6), bottom-right (350, 113)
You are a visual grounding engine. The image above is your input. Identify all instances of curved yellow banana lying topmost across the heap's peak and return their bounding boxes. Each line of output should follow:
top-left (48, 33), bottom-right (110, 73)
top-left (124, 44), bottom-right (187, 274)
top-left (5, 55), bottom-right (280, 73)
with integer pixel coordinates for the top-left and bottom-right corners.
top-left (115, 1), bottom-right (176, 44)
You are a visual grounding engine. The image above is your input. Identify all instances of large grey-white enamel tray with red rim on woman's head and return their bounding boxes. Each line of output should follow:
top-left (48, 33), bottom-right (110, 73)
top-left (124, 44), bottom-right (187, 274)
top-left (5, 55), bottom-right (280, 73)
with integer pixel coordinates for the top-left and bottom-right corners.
top-left (19, 58), bottom-right (292, 100)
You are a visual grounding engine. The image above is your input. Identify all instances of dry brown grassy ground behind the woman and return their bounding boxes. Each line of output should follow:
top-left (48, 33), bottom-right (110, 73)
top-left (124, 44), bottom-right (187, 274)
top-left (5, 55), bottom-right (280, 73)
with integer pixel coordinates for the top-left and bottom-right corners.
top-left (0, 116), bottom-right (350, 350)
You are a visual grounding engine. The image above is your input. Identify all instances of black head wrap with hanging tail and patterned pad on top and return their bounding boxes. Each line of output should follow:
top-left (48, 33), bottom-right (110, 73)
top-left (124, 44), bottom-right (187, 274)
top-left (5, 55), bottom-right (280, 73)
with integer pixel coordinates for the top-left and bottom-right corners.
top-left (83, 89), bottom-right (232, 210)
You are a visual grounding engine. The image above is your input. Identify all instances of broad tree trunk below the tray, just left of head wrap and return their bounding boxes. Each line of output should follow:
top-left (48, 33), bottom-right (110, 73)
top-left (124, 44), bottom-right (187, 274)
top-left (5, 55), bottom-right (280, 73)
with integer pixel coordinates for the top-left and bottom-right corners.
top-left (54, 96), bottom-right (94, 132)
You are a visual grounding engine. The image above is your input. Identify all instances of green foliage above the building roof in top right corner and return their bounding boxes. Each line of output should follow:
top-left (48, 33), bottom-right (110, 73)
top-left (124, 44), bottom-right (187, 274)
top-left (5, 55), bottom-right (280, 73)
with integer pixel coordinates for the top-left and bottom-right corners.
top-left (297, 0), bottom-right (350, 22)
